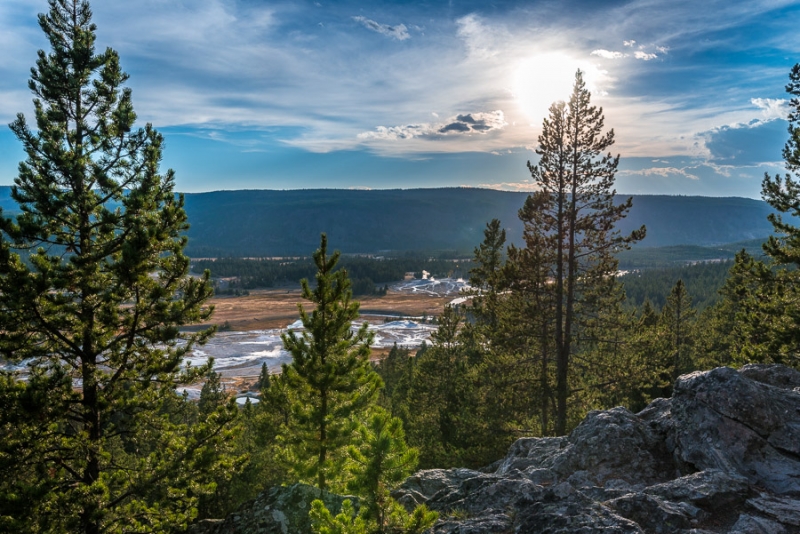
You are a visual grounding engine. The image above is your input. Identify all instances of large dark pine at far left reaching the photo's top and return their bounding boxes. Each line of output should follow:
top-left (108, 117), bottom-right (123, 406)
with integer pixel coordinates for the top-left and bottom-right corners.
top-left (0, 0), bottom-right (238, 534)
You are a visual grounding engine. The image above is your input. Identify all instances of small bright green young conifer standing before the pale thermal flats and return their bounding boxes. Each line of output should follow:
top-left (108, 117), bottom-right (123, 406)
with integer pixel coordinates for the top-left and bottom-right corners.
top-left (281, 234), bottom-right (382, 489)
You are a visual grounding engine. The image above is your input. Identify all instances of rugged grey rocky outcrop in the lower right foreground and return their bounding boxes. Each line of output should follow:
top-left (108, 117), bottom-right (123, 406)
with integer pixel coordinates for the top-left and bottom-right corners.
top-left (395, 365), bottom-right (800, 534)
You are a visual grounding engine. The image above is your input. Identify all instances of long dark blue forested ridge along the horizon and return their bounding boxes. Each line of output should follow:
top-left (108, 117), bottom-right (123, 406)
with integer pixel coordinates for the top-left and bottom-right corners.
top-left (178, 192), bottom-right (784, 257)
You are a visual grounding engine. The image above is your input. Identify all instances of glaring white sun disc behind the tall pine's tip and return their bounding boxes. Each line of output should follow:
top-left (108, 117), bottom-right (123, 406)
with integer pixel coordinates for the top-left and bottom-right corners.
top-left (513, 52), bottom-right (600, 126)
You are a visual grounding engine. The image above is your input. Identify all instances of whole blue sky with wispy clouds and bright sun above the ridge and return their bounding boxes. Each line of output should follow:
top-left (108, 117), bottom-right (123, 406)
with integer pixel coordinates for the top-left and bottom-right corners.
top-left (0, 0), bottom-right (800, 198)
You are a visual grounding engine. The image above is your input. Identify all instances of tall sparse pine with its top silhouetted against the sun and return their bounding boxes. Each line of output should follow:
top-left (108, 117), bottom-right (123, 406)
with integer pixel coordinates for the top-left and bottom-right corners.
top-left (520, 71), bottom-right (645, 435)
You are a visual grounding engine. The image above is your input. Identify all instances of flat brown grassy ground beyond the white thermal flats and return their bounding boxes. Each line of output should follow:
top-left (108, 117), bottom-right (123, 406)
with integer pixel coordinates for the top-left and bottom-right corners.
top-left (196, 288), bottom-right (453, 331)
